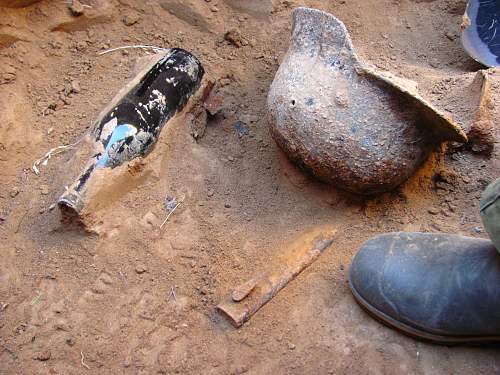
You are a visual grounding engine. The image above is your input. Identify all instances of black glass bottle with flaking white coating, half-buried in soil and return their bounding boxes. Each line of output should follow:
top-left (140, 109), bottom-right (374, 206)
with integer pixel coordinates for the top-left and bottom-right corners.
top-left (58, 48), bottom-right (204, 214)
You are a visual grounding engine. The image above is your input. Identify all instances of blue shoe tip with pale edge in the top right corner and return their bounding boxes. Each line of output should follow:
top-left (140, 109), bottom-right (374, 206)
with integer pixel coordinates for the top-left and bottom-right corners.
top-left (462, 0), bottom-right (500, 67)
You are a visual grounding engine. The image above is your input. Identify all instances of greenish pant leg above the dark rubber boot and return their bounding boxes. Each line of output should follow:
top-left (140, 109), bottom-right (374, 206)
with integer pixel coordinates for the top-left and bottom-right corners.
top-left (480, 178), bottom-right (500, 252)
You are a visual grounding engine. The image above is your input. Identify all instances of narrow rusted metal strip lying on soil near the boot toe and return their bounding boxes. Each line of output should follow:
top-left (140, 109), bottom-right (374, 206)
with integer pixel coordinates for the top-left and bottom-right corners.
top-left (217, 229), bottom-right (335, 327)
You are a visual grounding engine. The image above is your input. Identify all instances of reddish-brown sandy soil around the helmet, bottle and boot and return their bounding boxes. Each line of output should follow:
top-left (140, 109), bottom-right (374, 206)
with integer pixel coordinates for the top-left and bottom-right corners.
top-left (0, 0), bottom-right (500, 374)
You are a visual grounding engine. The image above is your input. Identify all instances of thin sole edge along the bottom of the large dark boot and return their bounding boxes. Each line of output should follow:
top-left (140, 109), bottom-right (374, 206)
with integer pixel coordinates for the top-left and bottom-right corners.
top-left (349, 276), bottom-right (500, 345)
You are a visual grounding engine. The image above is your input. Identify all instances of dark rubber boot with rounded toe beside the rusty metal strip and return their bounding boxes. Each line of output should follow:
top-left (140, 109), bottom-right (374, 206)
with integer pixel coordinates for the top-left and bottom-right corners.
top-left (349, 233), bottom-right (500, 344)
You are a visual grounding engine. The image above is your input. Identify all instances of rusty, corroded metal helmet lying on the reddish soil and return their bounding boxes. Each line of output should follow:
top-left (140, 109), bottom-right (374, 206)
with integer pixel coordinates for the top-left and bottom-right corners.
top-left (268, 8), bottom-right (467, 194)
